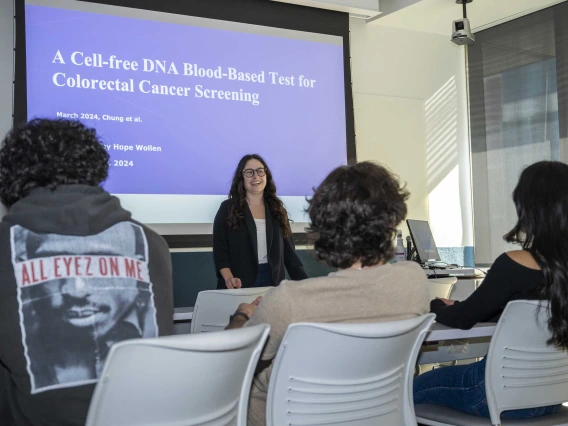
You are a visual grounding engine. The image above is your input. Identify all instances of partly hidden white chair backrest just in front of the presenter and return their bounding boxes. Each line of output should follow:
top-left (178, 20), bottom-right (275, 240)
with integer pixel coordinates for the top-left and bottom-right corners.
top-left (191, 287), bottom-right (274, 333)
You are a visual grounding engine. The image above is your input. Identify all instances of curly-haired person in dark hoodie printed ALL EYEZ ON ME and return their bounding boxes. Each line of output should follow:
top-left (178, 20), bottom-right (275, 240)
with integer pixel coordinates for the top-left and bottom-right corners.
top-left (0, 119), bottom-right (173, 426)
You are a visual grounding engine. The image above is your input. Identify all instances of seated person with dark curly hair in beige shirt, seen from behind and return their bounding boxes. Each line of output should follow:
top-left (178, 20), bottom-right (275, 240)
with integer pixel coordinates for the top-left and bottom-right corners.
top-left (227, 162), bottom-right (429, 426)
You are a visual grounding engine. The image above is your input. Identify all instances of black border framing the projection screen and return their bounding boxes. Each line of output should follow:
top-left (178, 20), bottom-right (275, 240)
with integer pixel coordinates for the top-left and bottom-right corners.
top-left (13, 0), bottom-right (357, 248)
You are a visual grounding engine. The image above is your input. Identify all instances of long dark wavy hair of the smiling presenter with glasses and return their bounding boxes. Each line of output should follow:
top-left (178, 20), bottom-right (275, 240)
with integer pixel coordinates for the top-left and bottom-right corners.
top-left (227, 154), bottom-right (292, 238)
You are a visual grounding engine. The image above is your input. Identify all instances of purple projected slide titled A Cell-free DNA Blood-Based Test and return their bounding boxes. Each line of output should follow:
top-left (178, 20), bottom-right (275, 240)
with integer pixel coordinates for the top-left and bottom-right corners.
top-left (26, 5), bottom-right (347, 196)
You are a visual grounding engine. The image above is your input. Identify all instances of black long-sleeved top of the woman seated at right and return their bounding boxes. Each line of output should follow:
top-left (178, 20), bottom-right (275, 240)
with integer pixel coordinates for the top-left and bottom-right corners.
top-left (430, 253), bottom-right (544, 330)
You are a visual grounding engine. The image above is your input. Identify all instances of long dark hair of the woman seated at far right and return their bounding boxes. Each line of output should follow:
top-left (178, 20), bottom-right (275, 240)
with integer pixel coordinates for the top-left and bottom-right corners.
top-left (504, 161), bottom-right (568, 349)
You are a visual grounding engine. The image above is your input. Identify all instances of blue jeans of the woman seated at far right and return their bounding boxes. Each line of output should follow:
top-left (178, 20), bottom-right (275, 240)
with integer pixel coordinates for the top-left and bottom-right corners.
top-left (414, 358), bottom-right (561, 419)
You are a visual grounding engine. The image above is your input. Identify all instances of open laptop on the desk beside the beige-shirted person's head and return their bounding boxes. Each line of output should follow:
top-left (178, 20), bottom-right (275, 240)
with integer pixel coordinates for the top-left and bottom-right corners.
top-left (406, 219), bottom-right (475, 277)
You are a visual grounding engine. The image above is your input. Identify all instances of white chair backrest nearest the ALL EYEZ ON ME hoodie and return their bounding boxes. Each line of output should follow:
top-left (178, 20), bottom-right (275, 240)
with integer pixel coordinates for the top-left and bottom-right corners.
top-left (87, 324), bottom-right (270, 426)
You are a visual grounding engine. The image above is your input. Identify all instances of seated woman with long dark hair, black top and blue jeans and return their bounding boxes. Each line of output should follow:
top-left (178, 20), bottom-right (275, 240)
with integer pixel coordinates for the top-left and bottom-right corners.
top-left (414, 161), bottom-right (568, 419)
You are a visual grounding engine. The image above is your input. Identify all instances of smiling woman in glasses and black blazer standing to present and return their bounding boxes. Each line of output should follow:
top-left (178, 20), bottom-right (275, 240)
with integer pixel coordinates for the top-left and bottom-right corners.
top-left (213, 154), bottom-right (308, 289)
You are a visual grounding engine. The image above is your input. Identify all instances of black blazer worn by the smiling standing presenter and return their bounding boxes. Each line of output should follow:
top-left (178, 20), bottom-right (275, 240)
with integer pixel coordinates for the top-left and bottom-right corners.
top-left (213, 200), bottom-right (308, 289)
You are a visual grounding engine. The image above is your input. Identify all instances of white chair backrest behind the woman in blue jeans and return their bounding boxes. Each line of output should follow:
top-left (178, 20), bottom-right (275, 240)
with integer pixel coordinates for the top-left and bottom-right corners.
top-left (485, 300), bottom-right (568, 424)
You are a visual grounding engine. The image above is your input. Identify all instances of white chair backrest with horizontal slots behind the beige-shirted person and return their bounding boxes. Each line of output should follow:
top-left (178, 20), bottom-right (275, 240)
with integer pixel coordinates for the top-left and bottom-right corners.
top-left (266, 314), bottom-right (434, 426)
